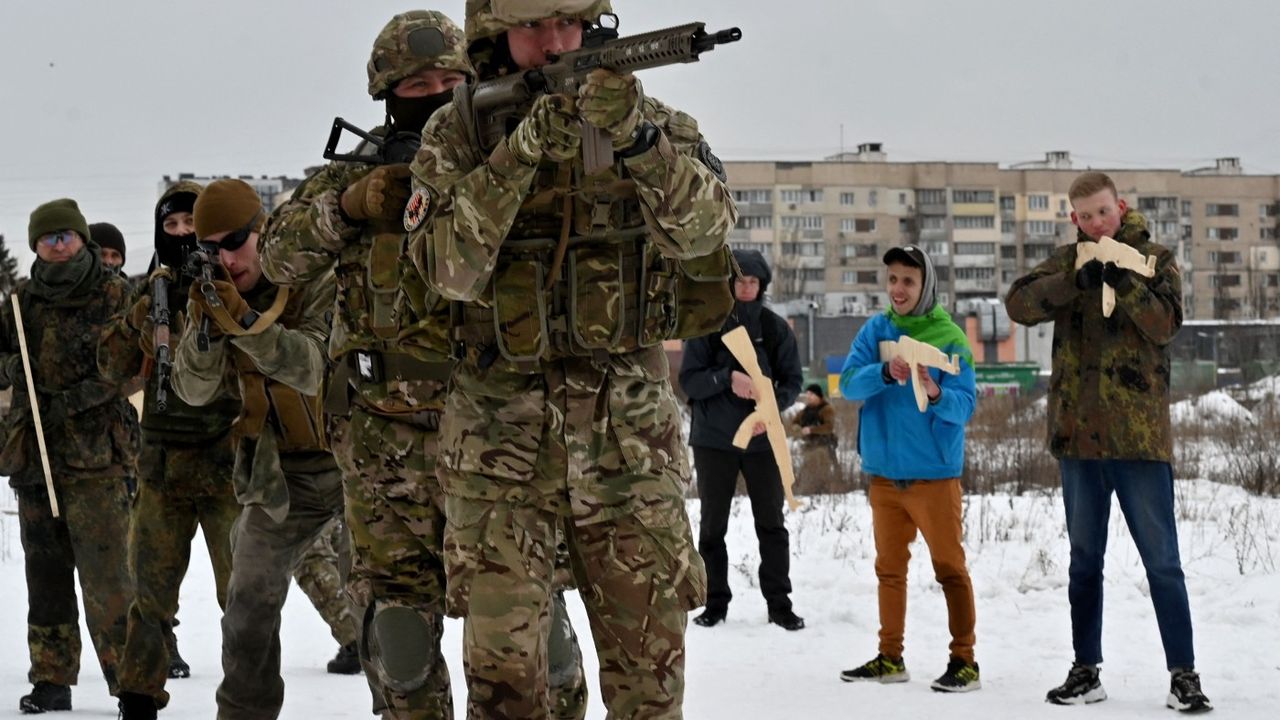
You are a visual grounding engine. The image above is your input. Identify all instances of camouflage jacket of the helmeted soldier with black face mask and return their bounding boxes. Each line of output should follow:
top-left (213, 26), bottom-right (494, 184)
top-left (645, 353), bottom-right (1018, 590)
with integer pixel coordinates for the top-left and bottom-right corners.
top-left (261, 135), bottom-right (449, 413)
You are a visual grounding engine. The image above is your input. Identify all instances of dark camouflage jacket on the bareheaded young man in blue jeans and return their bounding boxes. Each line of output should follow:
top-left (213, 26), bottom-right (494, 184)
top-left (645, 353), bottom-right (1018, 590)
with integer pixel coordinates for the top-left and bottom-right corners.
top-left (1005, 210), bottom-right (1183, 462)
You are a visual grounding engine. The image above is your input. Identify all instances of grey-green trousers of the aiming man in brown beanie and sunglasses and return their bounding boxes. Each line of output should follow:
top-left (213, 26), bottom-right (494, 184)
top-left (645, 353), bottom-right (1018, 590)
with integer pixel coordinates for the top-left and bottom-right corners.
top-left (216, 461), bottom-right (342, 720)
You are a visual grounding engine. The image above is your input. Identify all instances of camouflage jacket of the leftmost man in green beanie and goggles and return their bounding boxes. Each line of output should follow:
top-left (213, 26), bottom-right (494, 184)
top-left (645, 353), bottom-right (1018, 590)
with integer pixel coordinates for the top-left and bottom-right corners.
top-left (0, 265), bottom-right (140, 487)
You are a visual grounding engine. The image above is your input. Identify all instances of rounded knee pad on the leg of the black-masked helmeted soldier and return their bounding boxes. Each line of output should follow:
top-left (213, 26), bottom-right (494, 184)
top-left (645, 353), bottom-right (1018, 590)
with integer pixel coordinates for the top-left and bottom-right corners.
top-left (365, 605), bottom-right (443, 693)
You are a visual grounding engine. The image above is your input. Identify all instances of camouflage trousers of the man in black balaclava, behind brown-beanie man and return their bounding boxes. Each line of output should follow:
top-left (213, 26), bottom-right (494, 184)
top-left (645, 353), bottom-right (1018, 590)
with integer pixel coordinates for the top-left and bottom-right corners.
top-left (120, 461), bottom-right (241, 707)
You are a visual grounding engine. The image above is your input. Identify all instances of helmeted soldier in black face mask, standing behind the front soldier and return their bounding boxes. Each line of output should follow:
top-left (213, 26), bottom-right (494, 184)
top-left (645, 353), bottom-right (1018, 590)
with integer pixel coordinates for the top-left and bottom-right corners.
top-left (262, 10), bottom-right (586, 719)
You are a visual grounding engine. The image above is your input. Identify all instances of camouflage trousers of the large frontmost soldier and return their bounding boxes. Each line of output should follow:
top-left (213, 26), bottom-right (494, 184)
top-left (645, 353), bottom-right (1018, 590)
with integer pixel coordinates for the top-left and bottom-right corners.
top-left (439, 348), bottom-right (707, 720)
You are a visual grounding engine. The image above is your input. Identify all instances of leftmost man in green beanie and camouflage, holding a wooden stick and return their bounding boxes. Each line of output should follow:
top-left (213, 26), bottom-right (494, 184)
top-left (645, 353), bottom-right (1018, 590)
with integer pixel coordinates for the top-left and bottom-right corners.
top-left (0, 199), bottom-right (137, 712)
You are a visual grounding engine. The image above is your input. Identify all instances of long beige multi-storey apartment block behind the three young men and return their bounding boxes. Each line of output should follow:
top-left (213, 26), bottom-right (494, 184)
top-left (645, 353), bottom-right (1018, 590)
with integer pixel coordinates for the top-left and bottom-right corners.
top-left (724, 143), bottom-right (1280, 319)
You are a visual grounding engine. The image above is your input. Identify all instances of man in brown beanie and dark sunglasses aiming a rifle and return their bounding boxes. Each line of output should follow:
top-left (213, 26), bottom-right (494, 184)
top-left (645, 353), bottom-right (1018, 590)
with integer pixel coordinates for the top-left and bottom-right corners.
top-left (158, 179), bottom-right (342, 720)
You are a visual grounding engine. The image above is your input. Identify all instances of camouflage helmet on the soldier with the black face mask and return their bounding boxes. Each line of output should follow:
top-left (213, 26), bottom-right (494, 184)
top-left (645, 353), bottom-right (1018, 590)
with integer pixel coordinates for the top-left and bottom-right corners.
top-left (369, 10), bottom-right (475, 100)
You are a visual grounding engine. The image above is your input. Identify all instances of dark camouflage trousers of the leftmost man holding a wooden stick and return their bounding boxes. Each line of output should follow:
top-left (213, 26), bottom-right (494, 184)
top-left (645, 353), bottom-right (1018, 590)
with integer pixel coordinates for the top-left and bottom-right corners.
top-left (17, 478), bottom-right (133, 694)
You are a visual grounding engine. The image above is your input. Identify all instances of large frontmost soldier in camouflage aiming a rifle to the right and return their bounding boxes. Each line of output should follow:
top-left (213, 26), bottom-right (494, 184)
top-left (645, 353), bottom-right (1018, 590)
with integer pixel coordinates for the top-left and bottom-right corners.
top-left (404, 0), bottom-right (737, 719)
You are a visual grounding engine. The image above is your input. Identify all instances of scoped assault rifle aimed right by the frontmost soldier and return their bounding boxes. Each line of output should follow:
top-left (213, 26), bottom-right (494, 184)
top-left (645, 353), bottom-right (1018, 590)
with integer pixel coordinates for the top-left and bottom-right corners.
top-left (471, 13), bottom-right (742, 176)
